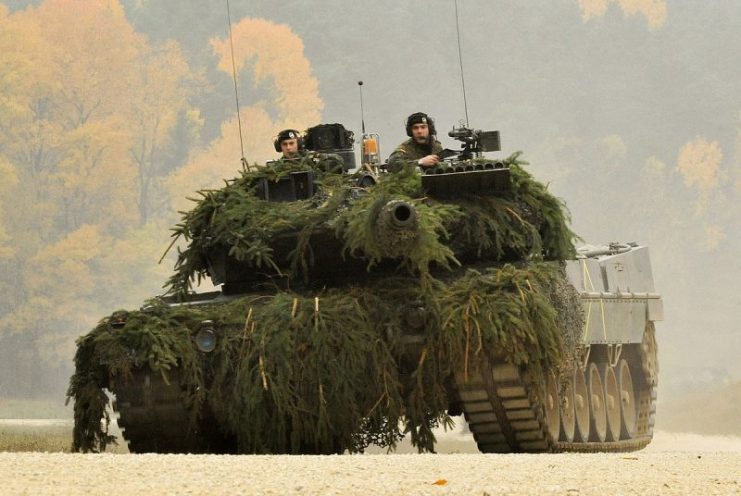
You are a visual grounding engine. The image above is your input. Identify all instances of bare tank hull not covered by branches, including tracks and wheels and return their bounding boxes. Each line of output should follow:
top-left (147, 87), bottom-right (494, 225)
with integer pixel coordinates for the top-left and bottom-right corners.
top-left (110, 247), bottom-right (662, 453)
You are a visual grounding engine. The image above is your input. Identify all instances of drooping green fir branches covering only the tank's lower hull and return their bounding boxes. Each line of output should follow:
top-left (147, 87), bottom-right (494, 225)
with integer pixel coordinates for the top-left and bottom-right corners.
top-left (68, 262), bottom-right (578, 453)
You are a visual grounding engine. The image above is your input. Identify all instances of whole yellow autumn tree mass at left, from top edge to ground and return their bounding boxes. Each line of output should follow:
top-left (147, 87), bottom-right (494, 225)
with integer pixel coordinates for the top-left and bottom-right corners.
top-left (0, 0), bottom-right (200, 390)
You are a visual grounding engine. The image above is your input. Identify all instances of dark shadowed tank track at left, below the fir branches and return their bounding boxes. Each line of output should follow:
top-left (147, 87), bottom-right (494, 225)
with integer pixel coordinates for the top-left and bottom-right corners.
top-left (110, 369), bottom-right (206, 453)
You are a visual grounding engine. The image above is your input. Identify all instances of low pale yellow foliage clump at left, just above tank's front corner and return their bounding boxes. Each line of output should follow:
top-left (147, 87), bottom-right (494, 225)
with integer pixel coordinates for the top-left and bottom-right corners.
top-left (0, 224), bottom-right (170, 363)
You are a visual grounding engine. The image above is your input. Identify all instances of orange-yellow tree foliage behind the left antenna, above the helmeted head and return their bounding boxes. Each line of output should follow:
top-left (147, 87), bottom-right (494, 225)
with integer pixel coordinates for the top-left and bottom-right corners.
top-left (168, 19), bottom-right (324, 200)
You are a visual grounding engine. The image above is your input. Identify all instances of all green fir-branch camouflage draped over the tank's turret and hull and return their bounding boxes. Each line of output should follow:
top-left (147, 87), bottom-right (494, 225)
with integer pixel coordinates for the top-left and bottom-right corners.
top-left (68, 151), bottom-right (581, 453)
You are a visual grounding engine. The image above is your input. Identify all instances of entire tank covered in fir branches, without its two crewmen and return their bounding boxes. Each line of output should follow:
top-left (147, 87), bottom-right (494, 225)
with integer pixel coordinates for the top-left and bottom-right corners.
top-left (68, 124), bottom-right (662, 454)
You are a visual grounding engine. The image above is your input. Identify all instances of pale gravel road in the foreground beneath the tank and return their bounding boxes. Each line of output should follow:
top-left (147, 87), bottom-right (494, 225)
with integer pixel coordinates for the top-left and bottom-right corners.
top-left (0, 433), bottom-right (741, 496)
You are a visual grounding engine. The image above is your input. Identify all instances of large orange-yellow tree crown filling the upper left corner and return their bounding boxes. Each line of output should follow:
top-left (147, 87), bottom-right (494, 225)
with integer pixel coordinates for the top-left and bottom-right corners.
top-left (0, 0), bottom-right (197, 240)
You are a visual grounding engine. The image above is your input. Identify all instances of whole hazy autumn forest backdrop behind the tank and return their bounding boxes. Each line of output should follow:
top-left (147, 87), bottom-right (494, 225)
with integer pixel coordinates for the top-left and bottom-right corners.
top-left (0, 0), bottom-right (741, 430)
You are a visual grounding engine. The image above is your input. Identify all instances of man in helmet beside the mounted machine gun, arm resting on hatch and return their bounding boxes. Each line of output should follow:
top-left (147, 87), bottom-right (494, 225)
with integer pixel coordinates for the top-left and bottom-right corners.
top-left (388, 112), bottom-right (443, 172)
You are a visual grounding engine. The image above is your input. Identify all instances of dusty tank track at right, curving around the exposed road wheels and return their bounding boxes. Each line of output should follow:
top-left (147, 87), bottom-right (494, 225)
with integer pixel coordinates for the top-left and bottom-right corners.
top-left (454, 340), bottom-right (656, 453)
